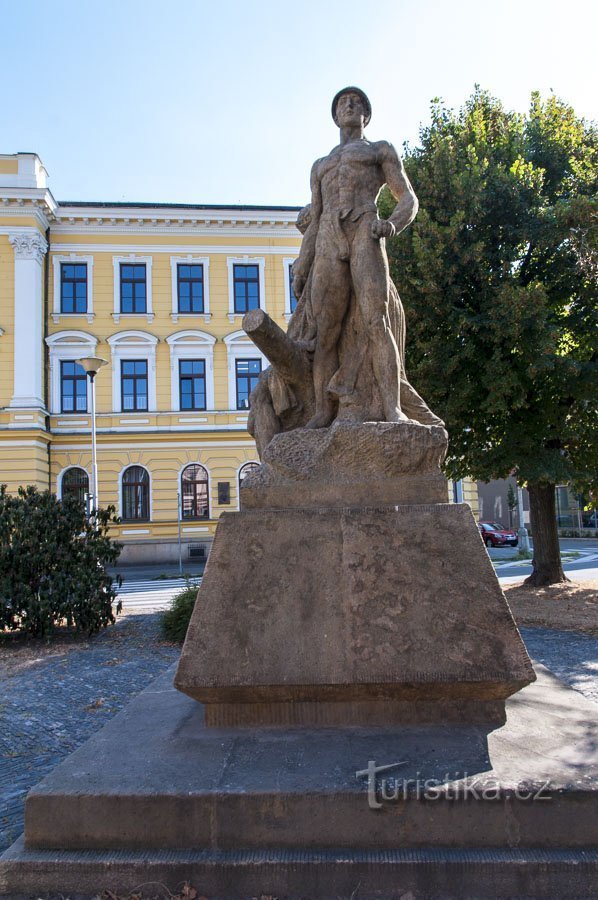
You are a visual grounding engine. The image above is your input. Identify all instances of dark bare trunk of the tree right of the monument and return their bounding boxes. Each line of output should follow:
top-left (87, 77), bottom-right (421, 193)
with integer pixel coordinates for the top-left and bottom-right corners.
top-left (523, 482), bottom-right (569, 587)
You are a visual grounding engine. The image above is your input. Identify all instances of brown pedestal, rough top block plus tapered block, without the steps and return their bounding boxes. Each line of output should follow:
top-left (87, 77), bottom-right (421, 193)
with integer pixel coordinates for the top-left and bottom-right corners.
top-left (175, 423), bottom-right (534, 726)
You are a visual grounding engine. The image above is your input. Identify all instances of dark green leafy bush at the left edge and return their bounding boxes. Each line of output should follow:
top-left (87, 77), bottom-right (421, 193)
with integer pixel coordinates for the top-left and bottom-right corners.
top-left (0, 485), bottom-right (122, 637)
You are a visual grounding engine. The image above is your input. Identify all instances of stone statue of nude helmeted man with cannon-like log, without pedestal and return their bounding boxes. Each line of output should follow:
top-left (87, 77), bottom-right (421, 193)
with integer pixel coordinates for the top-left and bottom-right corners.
top-left (243, 87), bottom-right (443, 456)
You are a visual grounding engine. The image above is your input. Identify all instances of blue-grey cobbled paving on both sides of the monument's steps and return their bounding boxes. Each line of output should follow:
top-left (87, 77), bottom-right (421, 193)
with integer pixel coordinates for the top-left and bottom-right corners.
top-left (0, 614), bottom-right (598, 850)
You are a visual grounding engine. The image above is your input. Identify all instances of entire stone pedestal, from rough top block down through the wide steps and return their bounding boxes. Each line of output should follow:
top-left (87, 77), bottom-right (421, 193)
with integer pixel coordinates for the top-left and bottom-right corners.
top-left (9, 423), bottom-right (598, 900)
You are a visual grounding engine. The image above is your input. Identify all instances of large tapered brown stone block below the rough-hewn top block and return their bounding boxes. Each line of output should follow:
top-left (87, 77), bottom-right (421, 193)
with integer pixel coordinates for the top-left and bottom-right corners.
top-left (175, 504), bottom-right (534, 724)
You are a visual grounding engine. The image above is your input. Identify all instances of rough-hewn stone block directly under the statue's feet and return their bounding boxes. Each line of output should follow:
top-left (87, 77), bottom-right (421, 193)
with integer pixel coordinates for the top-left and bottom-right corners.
top-left (241, 420), bottom-right (448, 508)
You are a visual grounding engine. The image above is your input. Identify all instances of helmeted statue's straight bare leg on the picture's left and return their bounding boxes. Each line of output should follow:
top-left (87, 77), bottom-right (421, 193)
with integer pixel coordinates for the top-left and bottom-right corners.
top-left (305, 246), bottom-right (351, 428)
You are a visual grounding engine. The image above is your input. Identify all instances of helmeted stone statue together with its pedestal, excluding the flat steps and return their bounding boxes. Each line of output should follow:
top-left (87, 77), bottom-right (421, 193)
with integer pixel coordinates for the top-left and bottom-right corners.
top-left (175, 88), bottom-right (534, 740)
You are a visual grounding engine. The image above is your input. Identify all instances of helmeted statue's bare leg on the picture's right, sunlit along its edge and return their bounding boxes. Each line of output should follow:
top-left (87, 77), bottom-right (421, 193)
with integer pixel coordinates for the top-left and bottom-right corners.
top-left (351, 223), bottom-right (407, 422)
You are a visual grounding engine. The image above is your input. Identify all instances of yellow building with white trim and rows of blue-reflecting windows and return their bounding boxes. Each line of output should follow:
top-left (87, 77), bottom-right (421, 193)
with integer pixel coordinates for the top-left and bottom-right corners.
top-left (0, 153), bottom-right (477, 562)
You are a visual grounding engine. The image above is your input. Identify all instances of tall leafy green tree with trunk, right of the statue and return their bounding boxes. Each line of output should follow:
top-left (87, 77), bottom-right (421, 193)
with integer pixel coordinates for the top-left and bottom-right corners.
top-left (380, 88), bottom-right (598, 585)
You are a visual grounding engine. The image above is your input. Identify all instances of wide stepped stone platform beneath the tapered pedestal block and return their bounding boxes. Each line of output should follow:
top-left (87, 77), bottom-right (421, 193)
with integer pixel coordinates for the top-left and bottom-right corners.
top-left (0, 667), bottom-right (598, 898)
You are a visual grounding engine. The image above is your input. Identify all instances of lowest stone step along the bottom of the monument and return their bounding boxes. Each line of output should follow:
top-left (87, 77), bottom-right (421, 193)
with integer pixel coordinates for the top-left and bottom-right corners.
top-left (0, 839), bottom-right (598, 900)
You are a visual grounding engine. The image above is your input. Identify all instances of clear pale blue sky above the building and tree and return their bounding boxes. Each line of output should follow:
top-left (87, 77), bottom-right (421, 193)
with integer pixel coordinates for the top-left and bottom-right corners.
top-left (0, 0), bottom-right (598, 205)
